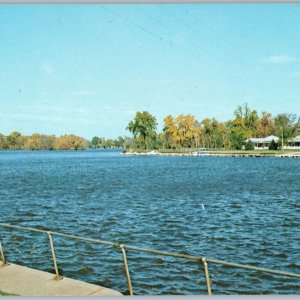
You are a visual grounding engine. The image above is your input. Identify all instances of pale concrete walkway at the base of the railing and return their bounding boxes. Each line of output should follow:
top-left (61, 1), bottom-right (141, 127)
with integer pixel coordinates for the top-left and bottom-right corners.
top-left (0, 261), bottom-right (122, 296)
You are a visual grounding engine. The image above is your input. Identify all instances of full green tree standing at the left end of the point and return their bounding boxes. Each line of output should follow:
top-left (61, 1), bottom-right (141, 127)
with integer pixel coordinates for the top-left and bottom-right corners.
top-left (126, 111), bottom-right (157, 149)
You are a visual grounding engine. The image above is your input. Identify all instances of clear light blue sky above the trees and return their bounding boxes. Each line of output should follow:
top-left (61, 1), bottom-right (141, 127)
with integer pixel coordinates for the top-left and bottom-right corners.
top-left (0, 4), bottom-right (300, 139)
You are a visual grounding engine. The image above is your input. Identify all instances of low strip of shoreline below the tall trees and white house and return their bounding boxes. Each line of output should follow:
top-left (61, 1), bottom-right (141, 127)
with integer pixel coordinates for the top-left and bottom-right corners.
top-left (123, 150), bottom-right (300, 158)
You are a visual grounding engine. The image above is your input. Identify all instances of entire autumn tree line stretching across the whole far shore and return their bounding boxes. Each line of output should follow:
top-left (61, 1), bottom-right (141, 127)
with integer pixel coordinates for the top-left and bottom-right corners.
top-left (0, 103), bottom-right (300, 150)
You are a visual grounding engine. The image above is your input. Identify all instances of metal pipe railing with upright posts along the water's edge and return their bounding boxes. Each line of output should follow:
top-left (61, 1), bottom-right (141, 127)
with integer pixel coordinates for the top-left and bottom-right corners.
top-left (0, 223), bottom-right (300, 295)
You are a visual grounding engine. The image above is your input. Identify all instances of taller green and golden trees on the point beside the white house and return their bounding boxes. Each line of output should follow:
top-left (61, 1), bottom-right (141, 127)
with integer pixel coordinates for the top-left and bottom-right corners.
top-left (127, 103), bottom-right (300, 150)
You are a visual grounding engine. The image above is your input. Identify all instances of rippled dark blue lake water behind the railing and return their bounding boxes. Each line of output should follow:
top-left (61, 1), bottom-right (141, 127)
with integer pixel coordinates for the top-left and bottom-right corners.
top-left (0, 151), bottom-right (300, 295)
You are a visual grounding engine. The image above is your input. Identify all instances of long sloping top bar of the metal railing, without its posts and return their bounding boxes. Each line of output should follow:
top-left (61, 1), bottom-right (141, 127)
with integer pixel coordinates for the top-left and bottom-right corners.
top-left (0, 223), bottom-right (300, 278)
